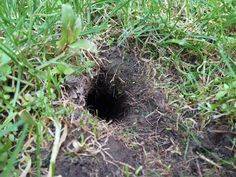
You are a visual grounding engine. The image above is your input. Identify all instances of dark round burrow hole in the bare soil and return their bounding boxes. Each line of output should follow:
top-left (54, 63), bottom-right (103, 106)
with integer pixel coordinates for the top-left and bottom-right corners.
top-left (86, 72), bottom-right (126, 121)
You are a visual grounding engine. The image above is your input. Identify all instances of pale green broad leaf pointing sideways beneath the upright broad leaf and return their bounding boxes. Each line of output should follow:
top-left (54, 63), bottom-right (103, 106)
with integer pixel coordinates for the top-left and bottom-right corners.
top-left (69, 39), bottom-right (97, 53)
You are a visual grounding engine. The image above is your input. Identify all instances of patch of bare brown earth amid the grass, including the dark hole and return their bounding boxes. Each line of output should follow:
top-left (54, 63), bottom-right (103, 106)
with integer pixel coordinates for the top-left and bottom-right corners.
top-left (55, 48), bottom-right (235, 177)
